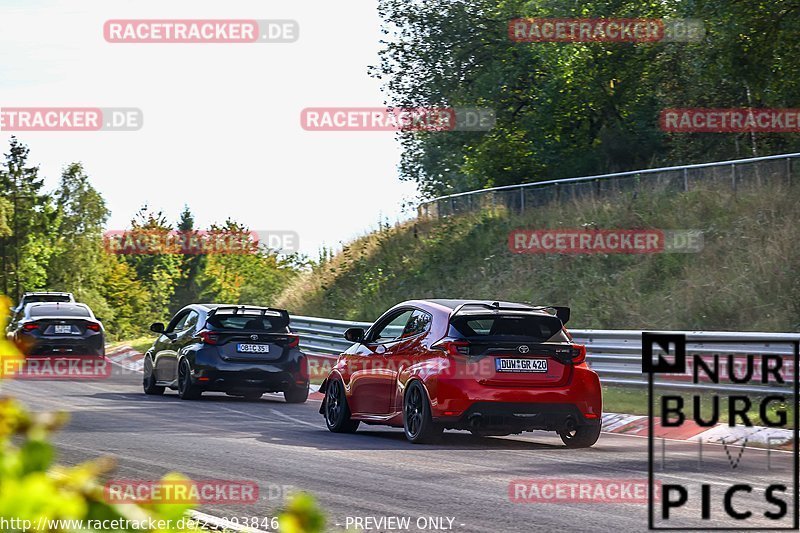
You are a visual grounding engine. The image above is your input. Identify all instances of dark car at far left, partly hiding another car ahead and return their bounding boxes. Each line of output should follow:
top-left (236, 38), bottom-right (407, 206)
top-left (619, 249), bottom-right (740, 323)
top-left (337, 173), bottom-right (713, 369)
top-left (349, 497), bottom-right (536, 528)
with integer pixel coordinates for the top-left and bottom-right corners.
top-left (8, 302), bottom-right (105, 356)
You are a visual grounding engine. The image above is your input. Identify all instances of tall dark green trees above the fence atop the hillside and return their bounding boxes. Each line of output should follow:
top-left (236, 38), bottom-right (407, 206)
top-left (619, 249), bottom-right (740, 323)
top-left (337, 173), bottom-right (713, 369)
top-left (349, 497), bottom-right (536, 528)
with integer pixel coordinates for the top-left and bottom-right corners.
top-left (371, 0), bottom-right (800, 197)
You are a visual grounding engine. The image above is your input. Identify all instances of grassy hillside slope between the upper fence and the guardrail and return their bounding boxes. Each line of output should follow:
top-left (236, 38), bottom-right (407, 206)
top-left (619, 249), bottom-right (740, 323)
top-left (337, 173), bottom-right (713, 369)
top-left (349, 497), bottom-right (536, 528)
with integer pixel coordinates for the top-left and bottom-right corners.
top-left (278, 185), bottom-right (800, 331)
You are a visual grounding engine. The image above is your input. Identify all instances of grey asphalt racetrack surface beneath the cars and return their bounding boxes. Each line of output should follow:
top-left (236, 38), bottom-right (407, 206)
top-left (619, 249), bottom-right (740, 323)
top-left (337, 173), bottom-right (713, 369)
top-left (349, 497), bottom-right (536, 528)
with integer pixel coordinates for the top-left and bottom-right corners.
top-left (0, 367), bottom-right (793, 532)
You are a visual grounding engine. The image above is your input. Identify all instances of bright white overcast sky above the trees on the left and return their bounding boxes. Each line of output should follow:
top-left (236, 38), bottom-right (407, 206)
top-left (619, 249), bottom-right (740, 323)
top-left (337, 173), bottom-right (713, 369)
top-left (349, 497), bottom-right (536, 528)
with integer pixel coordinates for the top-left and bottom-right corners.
top-left (0, 0), bottom-right (416, 257)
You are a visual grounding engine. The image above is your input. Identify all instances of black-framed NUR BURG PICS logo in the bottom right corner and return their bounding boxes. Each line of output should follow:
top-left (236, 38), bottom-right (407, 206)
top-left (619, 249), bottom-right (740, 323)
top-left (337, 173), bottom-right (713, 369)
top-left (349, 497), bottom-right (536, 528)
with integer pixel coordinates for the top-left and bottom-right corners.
top-left (642, 333), bottom-right (800, 531)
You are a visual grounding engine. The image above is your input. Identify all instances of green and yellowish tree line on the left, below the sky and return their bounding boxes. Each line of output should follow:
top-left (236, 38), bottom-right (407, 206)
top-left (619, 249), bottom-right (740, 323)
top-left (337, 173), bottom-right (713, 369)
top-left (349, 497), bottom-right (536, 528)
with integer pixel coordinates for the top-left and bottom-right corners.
top-left (0, 137), bottom-right (307, 338)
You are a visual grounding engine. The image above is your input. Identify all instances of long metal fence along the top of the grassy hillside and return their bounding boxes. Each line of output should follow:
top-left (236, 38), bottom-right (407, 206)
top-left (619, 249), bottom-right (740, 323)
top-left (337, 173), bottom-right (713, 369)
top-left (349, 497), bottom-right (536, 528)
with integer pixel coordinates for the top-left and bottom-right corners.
top-left (417, 153), bottom-right (800, 218)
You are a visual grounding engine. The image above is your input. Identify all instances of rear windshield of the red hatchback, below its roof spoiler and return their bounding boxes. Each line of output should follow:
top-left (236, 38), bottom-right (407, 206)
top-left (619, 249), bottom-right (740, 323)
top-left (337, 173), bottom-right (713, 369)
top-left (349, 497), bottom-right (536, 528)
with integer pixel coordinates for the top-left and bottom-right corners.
top-left (452, 315), bottom-right (569, 342)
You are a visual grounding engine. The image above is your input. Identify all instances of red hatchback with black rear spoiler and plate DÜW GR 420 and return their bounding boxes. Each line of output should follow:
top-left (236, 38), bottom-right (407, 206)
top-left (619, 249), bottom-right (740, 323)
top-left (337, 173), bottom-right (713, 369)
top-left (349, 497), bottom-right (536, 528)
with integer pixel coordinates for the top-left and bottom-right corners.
top-left (320, 300), bottom-right (603, 448)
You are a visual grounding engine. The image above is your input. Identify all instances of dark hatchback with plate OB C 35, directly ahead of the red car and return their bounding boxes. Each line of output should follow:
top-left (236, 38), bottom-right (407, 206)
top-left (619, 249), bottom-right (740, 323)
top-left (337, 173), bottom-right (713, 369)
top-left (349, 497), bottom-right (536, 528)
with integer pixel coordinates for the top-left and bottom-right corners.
top-left (142, 304), bottom-right (309, 403)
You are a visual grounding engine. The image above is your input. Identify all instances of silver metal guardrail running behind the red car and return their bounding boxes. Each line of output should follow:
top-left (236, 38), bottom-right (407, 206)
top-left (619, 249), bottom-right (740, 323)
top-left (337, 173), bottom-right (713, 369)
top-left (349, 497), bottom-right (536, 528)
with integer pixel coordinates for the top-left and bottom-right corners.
top-left (291, 316), bottom-right (800, 394)
